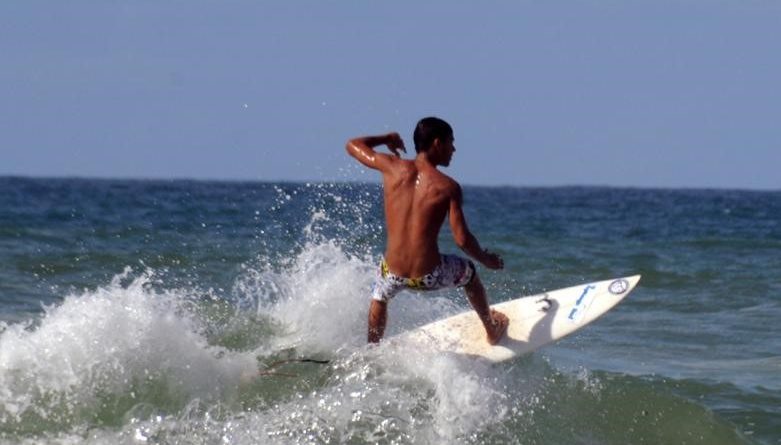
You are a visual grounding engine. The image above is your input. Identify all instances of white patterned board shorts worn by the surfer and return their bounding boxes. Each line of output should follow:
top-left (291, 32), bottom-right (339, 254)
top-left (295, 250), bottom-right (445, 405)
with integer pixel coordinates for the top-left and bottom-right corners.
top-left (372, 255), bottom-right (475, 301)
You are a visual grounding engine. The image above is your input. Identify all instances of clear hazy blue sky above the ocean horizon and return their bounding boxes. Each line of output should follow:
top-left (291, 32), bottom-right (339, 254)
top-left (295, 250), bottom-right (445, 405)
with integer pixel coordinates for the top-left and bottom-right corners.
top-left (0, 0), bottom-right (781, 189)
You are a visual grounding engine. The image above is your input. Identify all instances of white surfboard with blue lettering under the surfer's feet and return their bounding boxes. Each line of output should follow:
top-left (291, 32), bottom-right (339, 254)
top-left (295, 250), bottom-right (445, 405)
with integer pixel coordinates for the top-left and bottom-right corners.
top-left (402, 275), bottom-right (640, 362)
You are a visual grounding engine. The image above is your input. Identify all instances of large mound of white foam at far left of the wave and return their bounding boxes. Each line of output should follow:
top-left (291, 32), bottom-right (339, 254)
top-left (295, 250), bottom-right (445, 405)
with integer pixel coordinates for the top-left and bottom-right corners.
top-left (0, 270), bottom-right (253, 423)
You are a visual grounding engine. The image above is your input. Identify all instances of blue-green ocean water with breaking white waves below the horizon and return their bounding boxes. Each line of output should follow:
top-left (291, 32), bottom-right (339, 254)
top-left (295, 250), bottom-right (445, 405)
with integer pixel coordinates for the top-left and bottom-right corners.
top-left (0, 178), bottom-right (781, 445)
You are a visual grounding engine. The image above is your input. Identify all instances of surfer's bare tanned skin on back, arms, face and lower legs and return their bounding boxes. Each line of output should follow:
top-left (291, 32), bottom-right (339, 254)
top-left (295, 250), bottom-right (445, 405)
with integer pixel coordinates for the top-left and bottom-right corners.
top-left (346, 128), bottom-right (508, 344)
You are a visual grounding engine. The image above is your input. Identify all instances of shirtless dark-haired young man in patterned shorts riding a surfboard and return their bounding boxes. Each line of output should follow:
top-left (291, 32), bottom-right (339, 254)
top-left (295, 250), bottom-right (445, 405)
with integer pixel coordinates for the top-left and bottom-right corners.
top-left (347, 117), bottom-right (508, 345)
